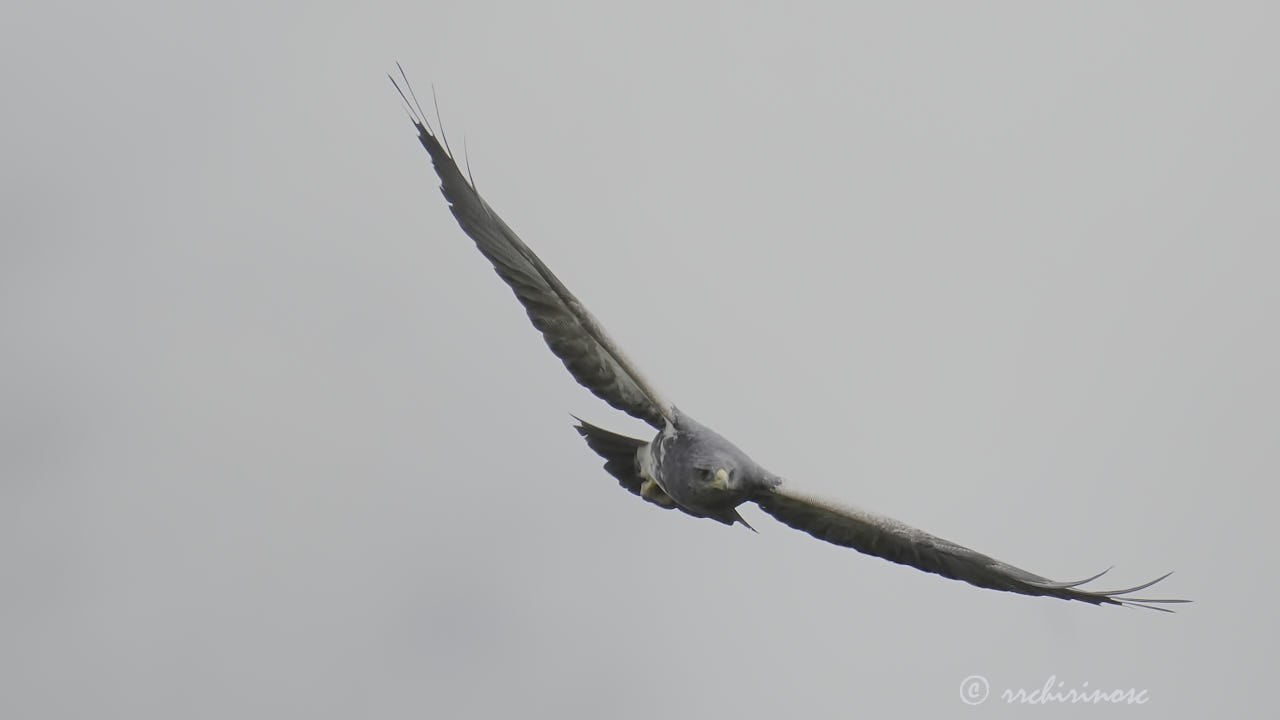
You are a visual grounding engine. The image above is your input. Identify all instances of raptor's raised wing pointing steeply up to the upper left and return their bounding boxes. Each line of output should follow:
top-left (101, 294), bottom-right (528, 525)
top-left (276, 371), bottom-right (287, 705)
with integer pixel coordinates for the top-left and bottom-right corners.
top-left (392, 70), bottom-right (672, 429)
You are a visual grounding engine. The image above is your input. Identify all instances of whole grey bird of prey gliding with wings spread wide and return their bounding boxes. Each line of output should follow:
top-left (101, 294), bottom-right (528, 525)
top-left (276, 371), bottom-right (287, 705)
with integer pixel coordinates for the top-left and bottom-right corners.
top-left (388, 65), bottom-right (1187, 612)
